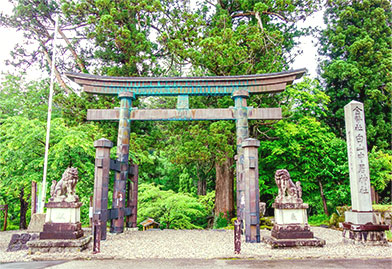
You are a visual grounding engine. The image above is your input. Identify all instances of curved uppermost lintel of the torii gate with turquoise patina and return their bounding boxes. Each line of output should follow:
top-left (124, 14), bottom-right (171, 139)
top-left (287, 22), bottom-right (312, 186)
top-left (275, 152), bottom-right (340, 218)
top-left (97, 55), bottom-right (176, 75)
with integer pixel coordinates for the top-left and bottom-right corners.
top-left (66, 69), bottom-right (306, 96)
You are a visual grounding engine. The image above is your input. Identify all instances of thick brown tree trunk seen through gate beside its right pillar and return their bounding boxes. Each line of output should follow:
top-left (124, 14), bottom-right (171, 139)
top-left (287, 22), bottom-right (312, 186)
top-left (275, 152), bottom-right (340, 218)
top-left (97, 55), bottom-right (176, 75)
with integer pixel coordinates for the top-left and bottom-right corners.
top-left (215, 157), bottom-right (234, 219)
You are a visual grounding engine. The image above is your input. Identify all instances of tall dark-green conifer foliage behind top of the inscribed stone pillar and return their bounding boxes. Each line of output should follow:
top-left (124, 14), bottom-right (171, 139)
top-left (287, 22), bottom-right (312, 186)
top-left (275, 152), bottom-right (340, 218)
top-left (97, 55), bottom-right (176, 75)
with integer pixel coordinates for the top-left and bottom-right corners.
top-left (320, 0), bottom-right (392, 149)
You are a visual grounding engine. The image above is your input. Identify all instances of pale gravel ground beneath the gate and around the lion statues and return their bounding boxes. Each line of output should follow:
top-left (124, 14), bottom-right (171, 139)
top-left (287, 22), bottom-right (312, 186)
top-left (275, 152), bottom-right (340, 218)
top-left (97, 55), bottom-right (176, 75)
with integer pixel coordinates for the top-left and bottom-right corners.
top-left (0, 227), bottom-right (392, 262)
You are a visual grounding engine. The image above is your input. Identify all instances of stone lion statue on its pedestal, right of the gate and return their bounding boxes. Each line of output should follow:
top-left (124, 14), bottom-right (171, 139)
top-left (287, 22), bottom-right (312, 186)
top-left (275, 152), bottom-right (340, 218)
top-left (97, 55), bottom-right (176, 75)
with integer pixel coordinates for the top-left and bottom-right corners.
top-left (263, 169), bottom-right (325, 247)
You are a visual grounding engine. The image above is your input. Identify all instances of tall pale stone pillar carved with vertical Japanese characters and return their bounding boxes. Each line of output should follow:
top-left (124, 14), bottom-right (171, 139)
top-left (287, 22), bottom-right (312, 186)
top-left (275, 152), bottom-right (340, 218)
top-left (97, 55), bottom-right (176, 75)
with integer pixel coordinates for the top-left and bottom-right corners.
top-left (343, 101), bottom-right (388, 245)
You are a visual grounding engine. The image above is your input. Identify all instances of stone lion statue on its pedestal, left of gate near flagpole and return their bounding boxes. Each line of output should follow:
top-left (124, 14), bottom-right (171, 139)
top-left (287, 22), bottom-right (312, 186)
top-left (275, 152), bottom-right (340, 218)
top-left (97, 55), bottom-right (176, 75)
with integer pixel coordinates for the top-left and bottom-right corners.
top-left (28, 167), bottom-right (91, 253)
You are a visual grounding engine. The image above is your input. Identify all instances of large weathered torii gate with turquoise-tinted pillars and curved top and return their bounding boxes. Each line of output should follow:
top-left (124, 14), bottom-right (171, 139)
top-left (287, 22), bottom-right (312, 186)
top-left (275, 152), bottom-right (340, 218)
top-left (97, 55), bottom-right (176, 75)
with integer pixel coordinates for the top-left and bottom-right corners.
top-left (66, 69), bottom-right (306, 242)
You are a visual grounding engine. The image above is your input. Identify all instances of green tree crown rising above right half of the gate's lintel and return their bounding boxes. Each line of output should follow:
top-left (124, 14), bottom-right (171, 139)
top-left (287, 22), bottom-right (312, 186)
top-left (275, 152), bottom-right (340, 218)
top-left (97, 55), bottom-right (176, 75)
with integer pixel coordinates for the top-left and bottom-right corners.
top-left (159, 1), bottom-right (318, 75)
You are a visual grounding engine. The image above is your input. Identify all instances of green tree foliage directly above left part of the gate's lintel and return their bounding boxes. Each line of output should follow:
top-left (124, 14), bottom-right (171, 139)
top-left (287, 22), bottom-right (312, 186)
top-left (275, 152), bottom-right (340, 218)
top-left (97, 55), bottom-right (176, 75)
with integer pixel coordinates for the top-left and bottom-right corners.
top-left (62, 0), bottom-right (162, 76)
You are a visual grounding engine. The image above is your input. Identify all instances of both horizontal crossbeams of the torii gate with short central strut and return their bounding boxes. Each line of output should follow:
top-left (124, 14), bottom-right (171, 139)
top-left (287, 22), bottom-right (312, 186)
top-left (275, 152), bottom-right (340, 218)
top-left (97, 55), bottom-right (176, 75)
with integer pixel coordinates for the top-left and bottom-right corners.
top-left (66, 69), bottom-right (306, 121)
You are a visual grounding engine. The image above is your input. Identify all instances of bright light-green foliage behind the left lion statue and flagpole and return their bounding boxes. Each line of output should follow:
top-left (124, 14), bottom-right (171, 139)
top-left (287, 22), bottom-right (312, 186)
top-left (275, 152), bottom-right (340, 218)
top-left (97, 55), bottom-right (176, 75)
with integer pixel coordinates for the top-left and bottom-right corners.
top-left (0, 116), bottom-right (98, 222)
